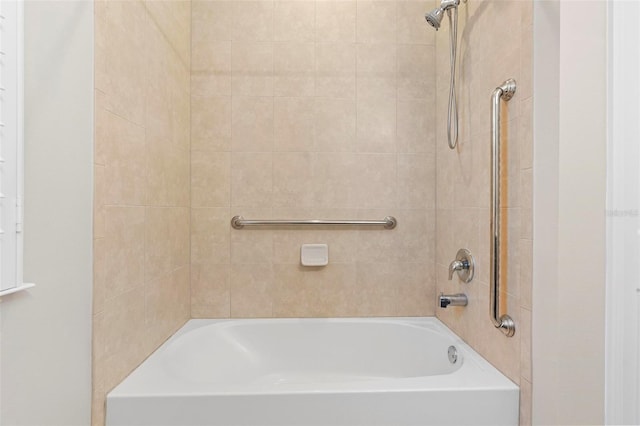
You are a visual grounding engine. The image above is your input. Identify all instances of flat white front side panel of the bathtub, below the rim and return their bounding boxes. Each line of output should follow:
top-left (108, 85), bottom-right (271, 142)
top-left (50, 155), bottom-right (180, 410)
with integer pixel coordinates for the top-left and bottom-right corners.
top-left (107, 389), bottom-right (518, 426)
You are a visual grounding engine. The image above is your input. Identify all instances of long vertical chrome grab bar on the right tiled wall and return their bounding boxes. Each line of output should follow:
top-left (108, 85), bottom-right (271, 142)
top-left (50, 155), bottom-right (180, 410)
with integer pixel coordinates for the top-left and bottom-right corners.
top-left (490, 79), bottom-right (516, 337)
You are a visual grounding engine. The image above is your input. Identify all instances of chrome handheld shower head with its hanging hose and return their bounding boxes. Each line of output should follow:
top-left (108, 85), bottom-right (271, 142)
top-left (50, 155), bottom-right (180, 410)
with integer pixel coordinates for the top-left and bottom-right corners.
top-left (424, 0), bottom-right (467, 149)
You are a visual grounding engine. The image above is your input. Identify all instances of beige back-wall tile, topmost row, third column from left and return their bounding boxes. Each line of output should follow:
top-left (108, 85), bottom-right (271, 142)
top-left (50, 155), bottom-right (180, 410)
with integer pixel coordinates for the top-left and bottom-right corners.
top-left (273, 0), bottom-right (316, 42)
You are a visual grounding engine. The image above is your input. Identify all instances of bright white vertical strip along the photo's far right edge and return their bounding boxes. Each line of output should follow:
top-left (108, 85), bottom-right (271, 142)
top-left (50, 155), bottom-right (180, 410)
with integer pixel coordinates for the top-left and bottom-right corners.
top-left (605, 1), bottom-right (640, 424)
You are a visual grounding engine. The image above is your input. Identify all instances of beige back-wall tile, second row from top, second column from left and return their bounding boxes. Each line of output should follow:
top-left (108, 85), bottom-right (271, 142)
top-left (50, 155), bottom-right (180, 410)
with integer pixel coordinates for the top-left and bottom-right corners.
top-left (231, 41), bottom-right (273, 96)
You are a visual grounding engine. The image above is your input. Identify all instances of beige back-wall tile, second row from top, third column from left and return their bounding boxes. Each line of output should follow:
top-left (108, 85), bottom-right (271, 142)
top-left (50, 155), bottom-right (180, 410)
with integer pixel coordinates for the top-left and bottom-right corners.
top-left (273, 42), bottom-right (316, 96)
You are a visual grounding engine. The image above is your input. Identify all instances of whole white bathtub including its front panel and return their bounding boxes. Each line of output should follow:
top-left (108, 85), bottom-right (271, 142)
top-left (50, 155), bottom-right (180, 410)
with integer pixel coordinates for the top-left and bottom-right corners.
top-left (107, 318), bottom-right (518, 426)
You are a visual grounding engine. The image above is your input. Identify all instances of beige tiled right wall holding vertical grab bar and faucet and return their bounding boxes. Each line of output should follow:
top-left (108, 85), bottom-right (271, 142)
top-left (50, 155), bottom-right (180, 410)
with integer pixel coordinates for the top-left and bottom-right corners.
top-left (436, 0), bottom-right (533, 425)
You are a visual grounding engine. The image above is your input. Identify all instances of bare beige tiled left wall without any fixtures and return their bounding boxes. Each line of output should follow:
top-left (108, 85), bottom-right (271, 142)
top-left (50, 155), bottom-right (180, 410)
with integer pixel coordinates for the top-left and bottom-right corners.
top-left (92, 1), bottom-right (191, 425)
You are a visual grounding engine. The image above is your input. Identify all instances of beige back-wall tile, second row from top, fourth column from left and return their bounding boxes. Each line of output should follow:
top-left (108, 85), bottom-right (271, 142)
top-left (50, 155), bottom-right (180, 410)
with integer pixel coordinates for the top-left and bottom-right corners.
top-left (316, 43), bottom-right (356, 98)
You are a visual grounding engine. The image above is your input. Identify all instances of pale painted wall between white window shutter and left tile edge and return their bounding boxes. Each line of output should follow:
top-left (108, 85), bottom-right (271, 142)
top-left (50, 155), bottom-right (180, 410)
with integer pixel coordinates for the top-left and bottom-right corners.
top-left (0, 1), bottom-right (93, 426)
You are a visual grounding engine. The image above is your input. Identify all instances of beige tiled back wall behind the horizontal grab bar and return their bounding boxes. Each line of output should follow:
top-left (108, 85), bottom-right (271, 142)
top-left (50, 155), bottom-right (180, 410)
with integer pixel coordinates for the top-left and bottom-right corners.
top-left (191, 0), bottom-right (435, 317)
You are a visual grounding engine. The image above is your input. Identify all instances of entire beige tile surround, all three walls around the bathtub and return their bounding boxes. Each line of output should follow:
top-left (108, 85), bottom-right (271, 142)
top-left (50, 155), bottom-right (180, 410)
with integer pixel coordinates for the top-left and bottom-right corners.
top-left (93, 0), bottom-right (532, 424)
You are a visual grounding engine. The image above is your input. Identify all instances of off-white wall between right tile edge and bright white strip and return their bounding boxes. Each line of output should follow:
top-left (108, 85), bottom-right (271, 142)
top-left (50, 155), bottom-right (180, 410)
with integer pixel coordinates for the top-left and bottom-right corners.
top-left (532, 1), bottom-right (606, 424)
